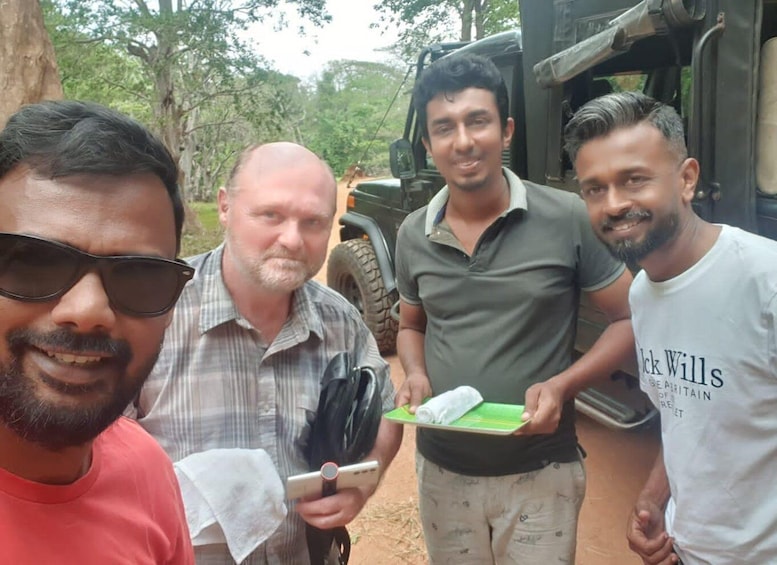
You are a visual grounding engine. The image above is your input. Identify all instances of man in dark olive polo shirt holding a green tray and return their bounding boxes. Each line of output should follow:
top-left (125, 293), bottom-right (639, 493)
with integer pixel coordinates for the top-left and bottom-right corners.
top-left (396, 54), bottom-right (634, 564)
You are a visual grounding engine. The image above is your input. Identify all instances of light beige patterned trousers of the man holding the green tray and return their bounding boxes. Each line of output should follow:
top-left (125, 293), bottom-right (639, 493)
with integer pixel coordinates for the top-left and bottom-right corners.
top-left (416, 452), bottom-right (585, 565)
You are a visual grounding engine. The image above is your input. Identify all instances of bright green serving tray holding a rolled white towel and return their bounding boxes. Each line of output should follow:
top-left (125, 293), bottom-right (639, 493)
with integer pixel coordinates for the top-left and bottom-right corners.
top-left (383, 402), bottom-right (528, 435)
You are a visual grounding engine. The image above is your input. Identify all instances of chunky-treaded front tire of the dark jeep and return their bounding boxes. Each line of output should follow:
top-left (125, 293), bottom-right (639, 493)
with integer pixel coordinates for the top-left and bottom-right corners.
top-left (326, 239), bottom-right (397, 354)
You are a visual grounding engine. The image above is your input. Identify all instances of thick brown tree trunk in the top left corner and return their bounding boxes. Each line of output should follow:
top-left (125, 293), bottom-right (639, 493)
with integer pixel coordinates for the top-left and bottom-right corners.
top-left (0, 0), bottom-right (62, 128)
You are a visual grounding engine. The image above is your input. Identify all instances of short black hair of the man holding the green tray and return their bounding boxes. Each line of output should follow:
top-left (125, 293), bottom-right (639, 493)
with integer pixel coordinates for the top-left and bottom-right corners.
top-left (413, 53), bottom-right (510, 140)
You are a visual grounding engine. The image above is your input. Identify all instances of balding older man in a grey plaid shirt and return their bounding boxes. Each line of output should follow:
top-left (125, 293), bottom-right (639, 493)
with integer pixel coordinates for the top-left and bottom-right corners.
top-left (128, 143), bottom-right (401, 565)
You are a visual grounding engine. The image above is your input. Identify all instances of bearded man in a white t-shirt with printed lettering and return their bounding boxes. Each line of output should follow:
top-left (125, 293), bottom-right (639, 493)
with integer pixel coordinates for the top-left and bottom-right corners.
top-left (566, 92), bottom-right (777, 565)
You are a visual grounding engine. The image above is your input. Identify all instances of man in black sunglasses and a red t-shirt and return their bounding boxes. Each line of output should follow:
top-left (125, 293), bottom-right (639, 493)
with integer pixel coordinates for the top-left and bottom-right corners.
top-left (0, 101), bottom-right (194, 564)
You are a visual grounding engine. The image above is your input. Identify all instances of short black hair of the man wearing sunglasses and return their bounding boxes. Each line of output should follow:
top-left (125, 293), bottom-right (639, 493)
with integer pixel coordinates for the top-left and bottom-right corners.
top-left (0, 100), bottom-right (184, 252)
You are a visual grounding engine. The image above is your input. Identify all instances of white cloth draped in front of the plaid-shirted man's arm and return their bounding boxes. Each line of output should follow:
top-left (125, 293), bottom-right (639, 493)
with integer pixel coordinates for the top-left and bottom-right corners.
top-left (174, 449), bottom-right (288, 563)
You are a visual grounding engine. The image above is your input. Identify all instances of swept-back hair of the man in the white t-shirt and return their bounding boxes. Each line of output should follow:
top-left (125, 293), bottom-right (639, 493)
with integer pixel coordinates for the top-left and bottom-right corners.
top-left (564, 92), bottom-right (688, 164)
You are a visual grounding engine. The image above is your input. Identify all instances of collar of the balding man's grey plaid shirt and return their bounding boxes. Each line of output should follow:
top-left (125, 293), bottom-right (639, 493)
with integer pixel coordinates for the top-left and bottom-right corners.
top-left (197, 243), bottom-right (324, 338)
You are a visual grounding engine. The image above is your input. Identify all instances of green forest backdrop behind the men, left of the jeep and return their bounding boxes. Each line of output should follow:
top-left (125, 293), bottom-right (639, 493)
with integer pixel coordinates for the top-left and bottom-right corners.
top-left (0, 0), bottom-right (519, 202)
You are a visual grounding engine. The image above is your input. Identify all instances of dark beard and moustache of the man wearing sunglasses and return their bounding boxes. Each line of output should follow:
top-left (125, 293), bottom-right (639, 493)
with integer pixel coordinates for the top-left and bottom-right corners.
top-left (0, 329), bottom-right (161, 451)
